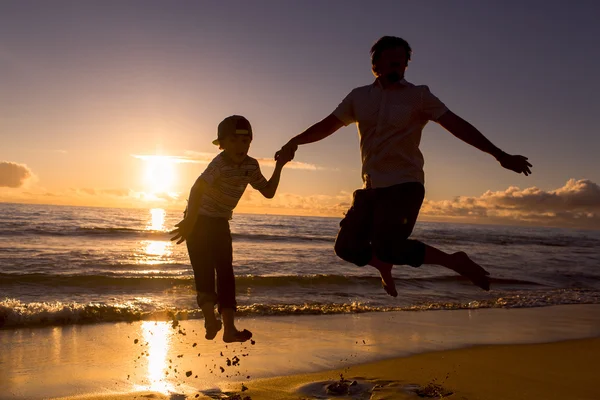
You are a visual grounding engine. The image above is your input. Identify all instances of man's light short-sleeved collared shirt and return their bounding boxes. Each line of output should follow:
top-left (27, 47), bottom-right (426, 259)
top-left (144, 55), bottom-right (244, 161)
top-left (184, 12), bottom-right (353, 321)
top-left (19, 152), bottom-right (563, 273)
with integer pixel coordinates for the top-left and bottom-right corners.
top-left (333, 79), bottom-right (448, 188)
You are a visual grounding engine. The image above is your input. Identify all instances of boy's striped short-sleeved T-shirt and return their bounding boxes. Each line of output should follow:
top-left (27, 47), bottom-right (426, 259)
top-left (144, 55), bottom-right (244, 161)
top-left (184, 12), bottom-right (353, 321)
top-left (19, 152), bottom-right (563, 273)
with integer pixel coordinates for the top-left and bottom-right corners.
top-left (199, 152), bottom-right (268, 219)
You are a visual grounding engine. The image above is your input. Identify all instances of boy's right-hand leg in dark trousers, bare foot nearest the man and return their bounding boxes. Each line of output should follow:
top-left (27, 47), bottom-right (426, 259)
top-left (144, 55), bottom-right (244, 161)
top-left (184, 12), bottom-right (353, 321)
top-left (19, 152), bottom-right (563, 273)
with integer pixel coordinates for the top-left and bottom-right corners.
top-left (213, 219), bottom-right (252, 343)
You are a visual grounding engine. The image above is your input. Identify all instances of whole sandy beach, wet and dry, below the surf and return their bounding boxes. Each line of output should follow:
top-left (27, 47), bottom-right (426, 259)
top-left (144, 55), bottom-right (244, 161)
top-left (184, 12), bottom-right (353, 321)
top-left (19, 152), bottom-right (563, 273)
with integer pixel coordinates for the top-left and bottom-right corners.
top-left (0, 305), bottom-right (600, 400)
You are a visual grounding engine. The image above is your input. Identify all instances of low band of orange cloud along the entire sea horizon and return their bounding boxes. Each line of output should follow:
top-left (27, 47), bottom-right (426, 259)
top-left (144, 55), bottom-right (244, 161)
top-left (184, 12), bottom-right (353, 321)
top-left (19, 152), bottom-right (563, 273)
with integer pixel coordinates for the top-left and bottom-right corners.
top-left (5, 179), bottom-right (600, 229)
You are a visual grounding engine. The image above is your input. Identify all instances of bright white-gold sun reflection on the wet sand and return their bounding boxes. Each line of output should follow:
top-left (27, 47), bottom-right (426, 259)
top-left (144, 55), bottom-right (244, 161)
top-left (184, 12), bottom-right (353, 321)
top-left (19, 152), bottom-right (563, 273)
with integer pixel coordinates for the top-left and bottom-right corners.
top-left (138, 321), bottom-right (175, 394)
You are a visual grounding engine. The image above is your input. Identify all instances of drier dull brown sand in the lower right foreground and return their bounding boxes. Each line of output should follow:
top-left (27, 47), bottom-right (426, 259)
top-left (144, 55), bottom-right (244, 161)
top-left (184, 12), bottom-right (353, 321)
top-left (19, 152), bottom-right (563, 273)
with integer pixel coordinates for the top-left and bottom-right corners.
top-left (53, 337), bottom-right (600, 400)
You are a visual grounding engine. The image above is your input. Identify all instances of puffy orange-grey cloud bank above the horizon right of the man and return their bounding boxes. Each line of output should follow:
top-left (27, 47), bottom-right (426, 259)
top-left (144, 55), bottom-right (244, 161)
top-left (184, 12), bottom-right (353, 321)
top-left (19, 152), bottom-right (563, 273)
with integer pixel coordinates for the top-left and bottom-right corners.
top-left (421, 179), bottom-right (600, 228)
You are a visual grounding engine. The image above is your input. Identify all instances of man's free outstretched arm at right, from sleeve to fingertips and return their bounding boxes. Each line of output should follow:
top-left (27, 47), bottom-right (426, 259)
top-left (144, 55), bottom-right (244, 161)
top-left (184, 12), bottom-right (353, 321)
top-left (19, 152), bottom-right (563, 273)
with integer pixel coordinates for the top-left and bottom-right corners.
top-left (437, 111), bottom-right (532, 175)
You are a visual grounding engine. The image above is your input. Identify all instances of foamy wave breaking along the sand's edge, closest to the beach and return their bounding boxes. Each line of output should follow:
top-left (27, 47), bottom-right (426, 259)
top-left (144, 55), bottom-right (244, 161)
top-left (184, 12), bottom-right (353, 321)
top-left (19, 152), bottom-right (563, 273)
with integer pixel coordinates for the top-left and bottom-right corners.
top-left (0, 289), bottom-right (600, 329)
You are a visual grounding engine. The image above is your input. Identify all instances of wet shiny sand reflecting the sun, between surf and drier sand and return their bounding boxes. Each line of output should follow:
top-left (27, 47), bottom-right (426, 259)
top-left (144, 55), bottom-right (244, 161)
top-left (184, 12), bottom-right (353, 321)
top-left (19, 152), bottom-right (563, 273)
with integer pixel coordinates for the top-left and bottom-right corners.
top-left (0, 305), bottom-right (600, 400)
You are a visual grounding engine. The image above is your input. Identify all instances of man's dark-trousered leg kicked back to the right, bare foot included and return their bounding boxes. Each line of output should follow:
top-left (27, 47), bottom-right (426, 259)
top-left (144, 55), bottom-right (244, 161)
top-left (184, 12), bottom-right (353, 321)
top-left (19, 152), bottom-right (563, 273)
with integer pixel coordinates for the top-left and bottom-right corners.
top-left (372, 183), bottom-right (489, 290)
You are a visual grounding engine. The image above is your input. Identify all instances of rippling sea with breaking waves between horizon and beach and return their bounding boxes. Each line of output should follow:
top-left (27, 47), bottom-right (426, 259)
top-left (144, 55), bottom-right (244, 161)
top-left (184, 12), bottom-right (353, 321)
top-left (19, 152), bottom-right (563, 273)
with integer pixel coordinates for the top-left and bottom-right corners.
top-left (0, 203), bottom-right (600, 329)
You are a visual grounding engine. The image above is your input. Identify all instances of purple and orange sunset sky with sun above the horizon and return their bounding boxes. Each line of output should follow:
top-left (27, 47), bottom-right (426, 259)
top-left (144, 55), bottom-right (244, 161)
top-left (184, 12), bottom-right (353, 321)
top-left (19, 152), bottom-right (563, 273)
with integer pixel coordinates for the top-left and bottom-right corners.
top-left (0, 0), bottom-right (600, 229)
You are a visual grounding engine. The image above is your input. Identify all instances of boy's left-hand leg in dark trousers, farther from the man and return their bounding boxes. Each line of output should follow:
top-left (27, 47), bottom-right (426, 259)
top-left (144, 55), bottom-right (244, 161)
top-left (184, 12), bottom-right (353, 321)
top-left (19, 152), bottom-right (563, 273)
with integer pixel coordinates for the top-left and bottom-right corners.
top-left (186, 216), bottom-right (221, 340)
